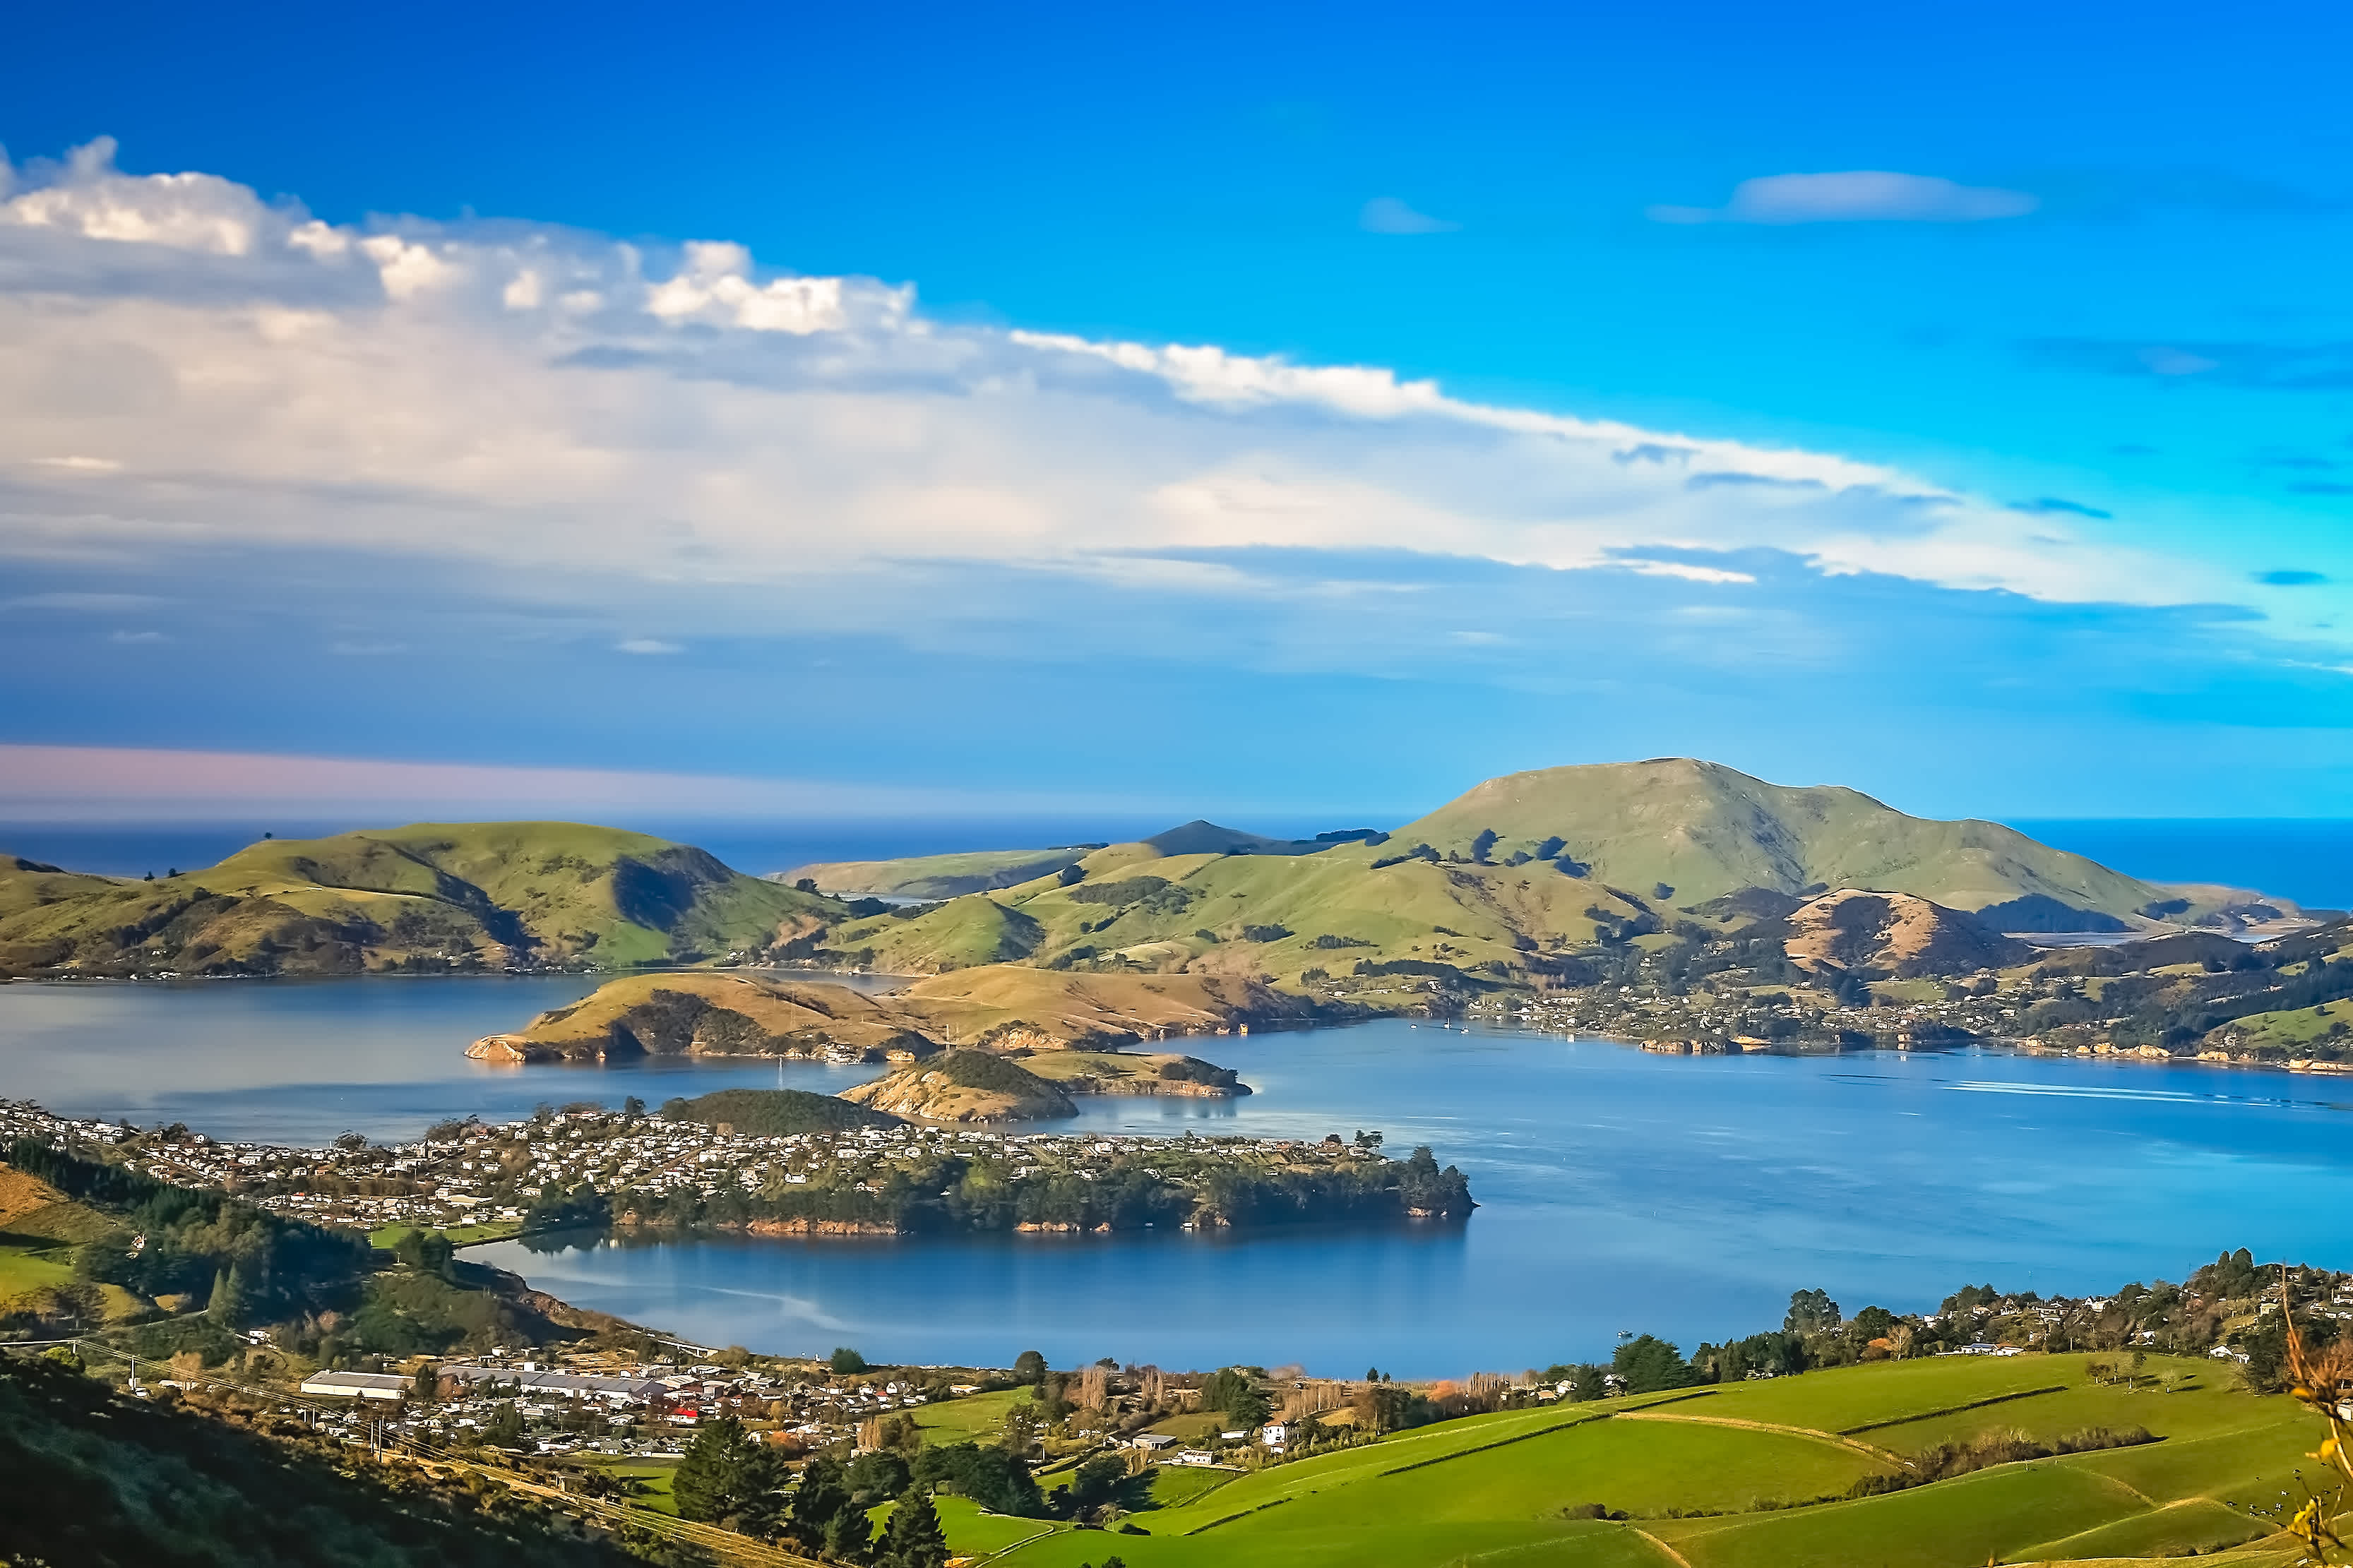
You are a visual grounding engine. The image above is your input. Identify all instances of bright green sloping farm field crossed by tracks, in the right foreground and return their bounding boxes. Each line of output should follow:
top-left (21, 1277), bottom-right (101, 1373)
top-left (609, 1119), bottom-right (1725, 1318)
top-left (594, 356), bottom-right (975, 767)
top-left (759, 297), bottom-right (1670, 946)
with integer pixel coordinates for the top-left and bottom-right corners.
top-left (948, 1354), bottom-right (2323, 1568)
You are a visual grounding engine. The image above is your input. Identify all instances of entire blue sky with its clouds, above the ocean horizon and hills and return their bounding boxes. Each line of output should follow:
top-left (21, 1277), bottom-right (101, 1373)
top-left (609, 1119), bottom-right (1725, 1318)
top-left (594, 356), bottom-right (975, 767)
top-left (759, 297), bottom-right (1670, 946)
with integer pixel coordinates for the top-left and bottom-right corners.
top-left (0, 5), bottom-right (2353, 822)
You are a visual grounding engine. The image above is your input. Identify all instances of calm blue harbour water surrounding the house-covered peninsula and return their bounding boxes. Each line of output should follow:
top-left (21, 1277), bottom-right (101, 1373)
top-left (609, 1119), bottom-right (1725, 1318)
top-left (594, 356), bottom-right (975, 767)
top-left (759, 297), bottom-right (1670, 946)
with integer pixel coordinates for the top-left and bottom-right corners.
top-left (0, 978), bottom-right (2353, 1375)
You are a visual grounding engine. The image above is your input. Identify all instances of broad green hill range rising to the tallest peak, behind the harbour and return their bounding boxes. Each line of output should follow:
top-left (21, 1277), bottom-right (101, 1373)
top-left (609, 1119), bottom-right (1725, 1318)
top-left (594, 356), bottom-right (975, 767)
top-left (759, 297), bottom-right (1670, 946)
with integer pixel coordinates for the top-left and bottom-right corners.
top-left (812, 757), bottom-right (2297, 985)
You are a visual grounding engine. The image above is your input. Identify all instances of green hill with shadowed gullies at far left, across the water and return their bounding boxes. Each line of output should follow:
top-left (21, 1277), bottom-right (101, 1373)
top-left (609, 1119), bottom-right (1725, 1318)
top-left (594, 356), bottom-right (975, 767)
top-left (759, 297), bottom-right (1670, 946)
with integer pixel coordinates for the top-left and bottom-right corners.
top-left (0, 822), bottom-right (840, 974)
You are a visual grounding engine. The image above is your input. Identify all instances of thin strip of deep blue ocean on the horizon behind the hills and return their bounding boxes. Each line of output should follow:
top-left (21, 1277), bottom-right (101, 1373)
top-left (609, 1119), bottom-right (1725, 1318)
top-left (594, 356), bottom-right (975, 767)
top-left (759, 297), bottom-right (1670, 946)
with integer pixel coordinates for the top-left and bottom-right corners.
top-left (0, 818), bottom-right (2353, 910)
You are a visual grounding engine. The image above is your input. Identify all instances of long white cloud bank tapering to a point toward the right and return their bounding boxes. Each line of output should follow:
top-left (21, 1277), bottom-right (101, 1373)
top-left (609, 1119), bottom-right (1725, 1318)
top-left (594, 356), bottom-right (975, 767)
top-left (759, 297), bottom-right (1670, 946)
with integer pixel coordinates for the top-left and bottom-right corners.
top-left (0, 135), bottom-right (2235, 625)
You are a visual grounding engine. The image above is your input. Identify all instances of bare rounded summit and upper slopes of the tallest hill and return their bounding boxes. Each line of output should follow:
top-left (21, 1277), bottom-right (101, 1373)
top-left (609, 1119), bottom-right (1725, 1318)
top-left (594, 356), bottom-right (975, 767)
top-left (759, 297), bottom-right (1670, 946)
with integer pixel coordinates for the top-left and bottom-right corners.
top-left (1393, 757), bottom-right (2167, 919)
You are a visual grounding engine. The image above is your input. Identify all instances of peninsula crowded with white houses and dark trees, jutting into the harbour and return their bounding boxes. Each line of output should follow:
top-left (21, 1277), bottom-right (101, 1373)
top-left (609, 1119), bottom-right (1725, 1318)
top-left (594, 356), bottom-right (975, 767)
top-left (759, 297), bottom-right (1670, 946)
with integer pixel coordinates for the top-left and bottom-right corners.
top-left (0, 1098), bottom-right (1468, 1239)
